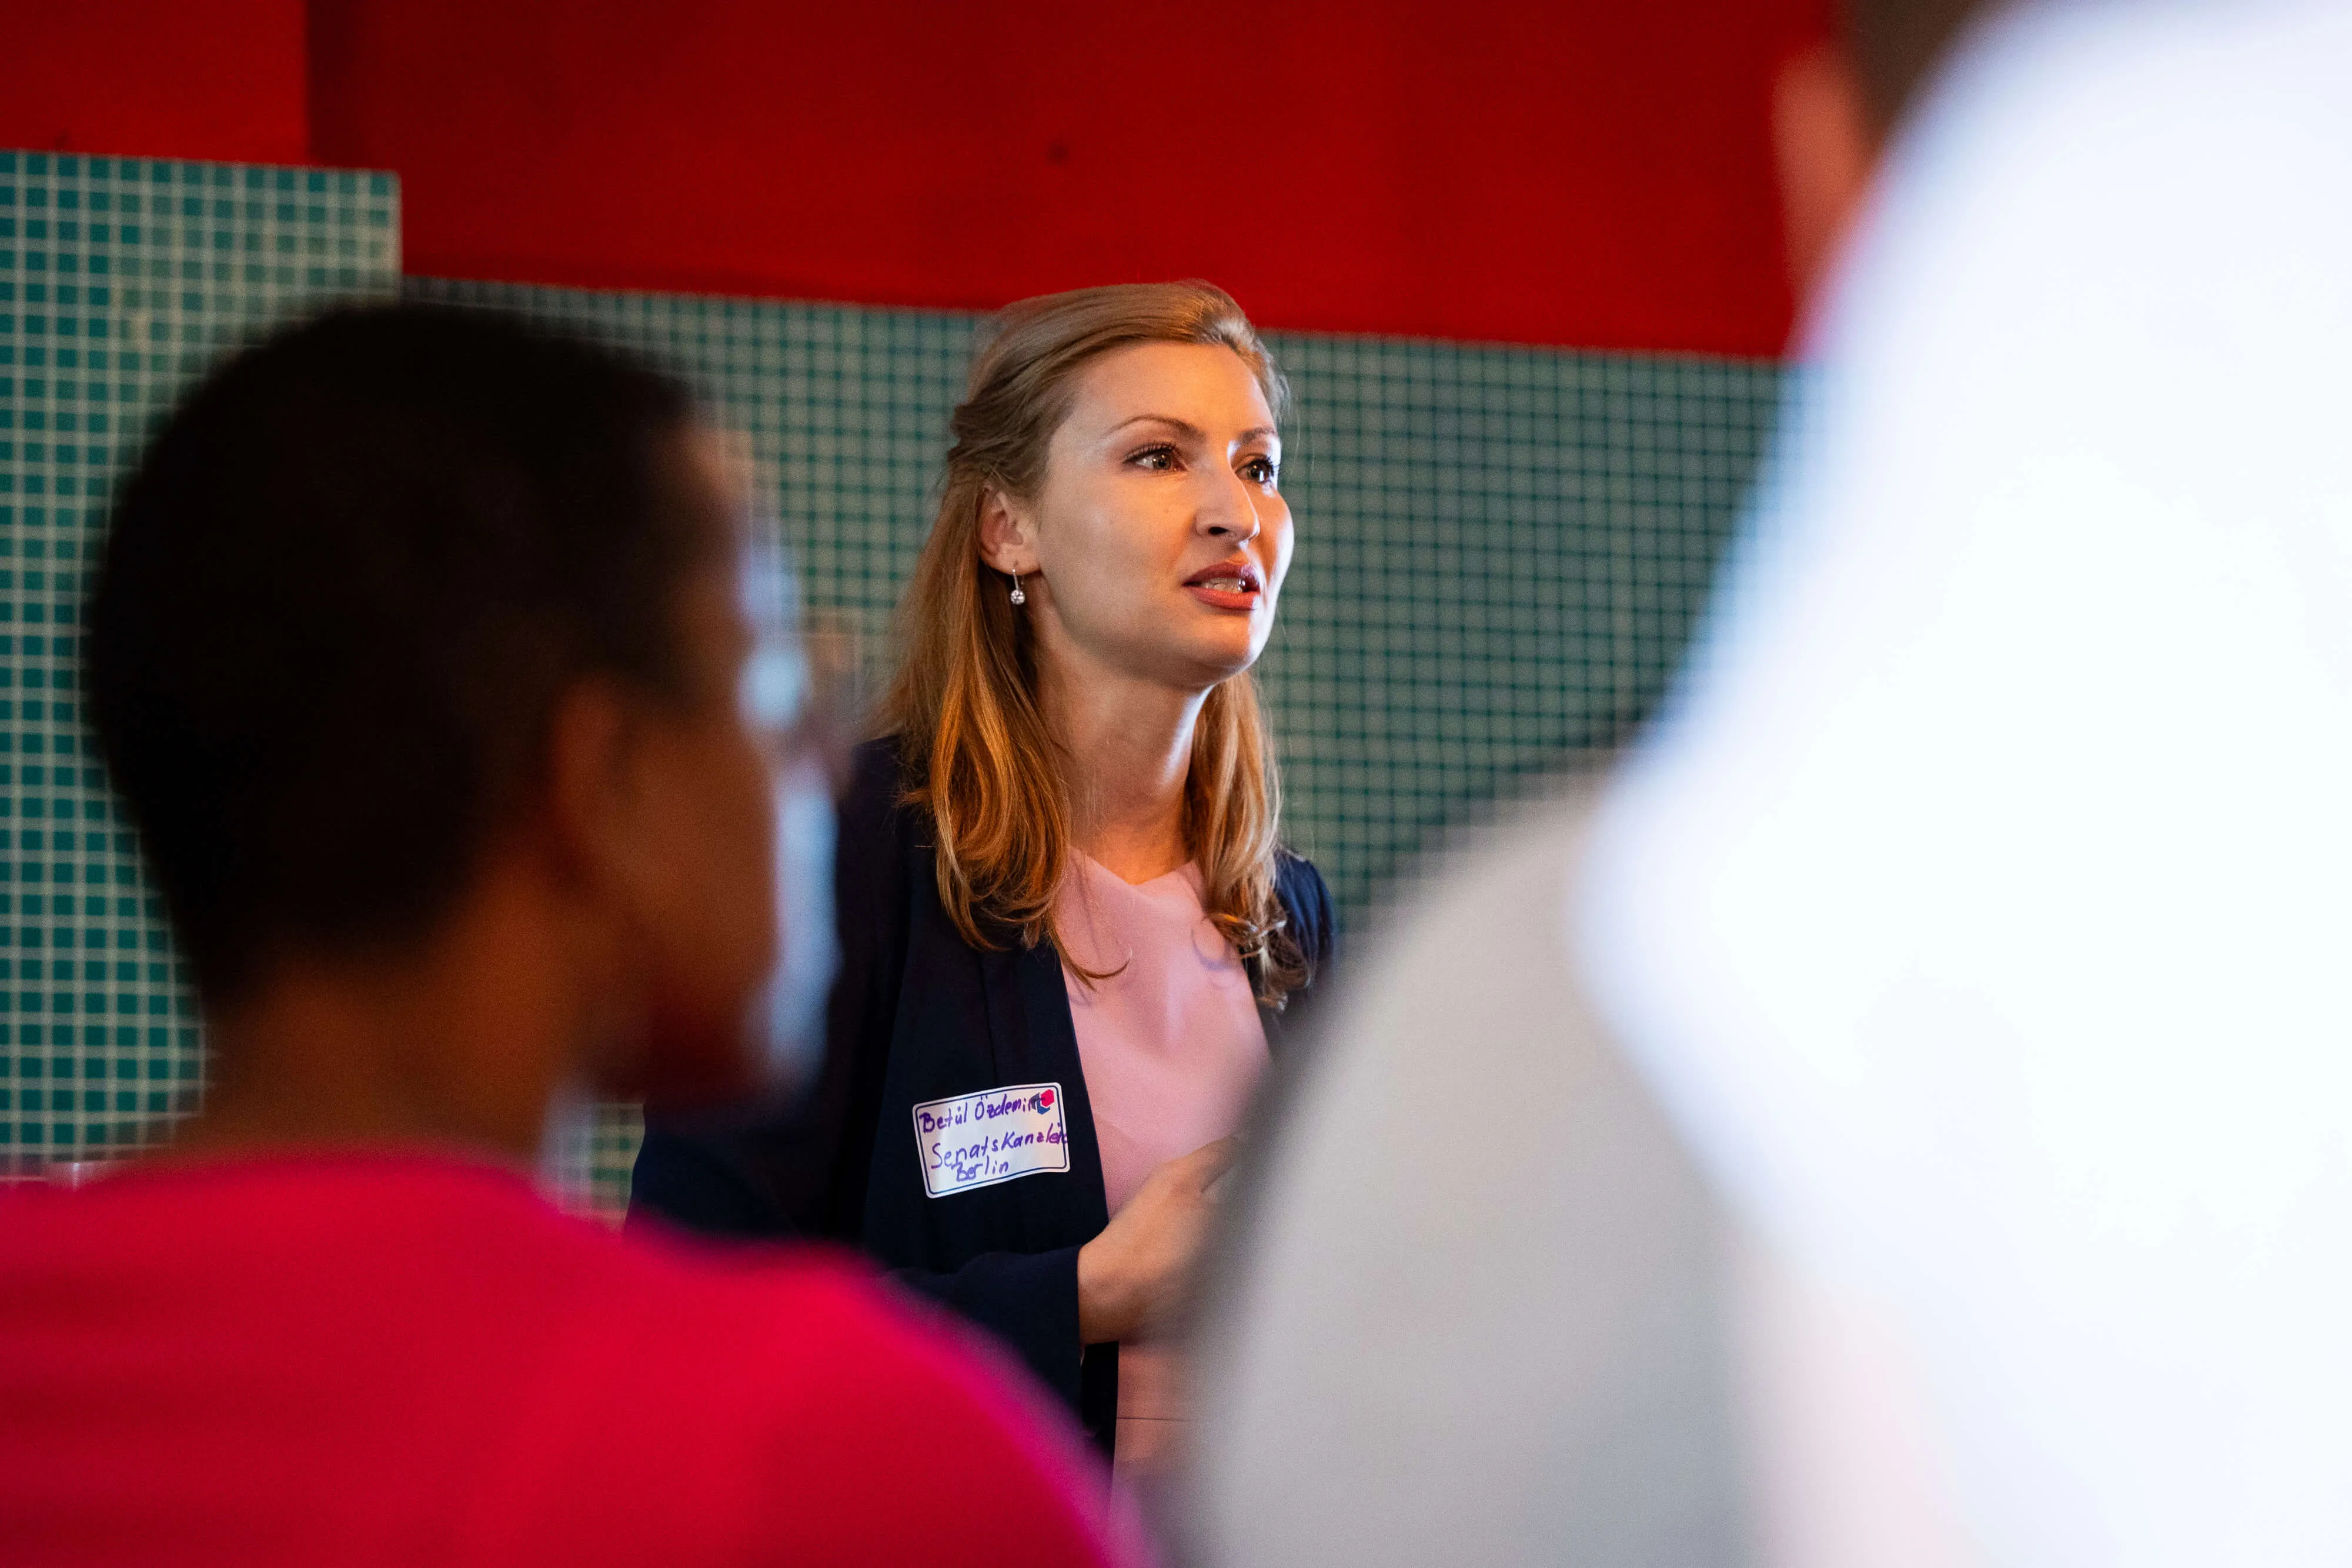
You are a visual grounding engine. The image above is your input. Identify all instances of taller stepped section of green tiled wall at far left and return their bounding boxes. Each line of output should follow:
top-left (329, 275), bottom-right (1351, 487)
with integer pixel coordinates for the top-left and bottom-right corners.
top-left (0, 153), bottom-right (400, 1173)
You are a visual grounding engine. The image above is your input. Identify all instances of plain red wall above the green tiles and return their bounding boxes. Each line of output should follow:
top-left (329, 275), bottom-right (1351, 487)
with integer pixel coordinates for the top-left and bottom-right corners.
top-left (0, 0), bottom-right (1818, 355)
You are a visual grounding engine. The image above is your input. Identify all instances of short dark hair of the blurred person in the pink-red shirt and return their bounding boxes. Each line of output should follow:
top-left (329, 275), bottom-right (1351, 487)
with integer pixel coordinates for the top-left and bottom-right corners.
top-left (85, 306), bottom-right (710, 999)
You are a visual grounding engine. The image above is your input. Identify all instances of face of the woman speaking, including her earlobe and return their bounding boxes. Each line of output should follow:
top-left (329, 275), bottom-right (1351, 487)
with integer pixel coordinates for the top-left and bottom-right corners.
top-left (983, 343), bottom-right (1291, 691)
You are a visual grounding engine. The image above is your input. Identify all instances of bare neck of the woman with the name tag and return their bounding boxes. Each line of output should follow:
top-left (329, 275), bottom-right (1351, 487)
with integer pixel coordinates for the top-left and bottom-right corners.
top-left (1040, 661), bottom-right (1209, 881)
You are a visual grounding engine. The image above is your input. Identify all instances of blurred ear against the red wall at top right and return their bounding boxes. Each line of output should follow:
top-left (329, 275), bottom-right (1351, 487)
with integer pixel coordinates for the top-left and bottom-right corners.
top-left (1771, 42), bottom-right (1879, 301)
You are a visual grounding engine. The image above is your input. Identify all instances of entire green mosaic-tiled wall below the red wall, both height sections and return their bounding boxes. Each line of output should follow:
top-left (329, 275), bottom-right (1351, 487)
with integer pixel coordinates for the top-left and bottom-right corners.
top-left (0, 177), bottom-right (1778, 1189)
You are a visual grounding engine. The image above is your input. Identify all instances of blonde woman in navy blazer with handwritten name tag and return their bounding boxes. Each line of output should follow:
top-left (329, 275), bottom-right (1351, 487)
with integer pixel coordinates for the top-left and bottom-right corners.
top-left (633, 285), bottom-right (1331, 1467)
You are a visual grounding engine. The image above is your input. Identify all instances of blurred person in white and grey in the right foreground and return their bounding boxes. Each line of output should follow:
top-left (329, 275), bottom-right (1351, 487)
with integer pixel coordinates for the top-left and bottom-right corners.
top-left (1192, 5), bottom-right (2352, 1568)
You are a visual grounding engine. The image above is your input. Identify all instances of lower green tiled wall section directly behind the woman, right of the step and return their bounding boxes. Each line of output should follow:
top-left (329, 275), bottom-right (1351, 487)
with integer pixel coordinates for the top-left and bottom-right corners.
top-left (407, 278), bottom-right (1778, 1213)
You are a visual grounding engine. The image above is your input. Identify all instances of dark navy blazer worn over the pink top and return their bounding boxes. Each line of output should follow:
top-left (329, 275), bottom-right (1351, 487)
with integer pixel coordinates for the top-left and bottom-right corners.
top-left (630, 741), bottom-right (1334, 1450)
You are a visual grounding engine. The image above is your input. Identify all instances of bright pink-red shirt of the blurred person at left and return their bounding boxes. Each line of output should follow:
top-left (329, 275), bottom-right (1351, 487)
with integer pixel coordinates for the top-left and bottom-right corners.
top-left (0, 1156), bottom-right (1131, 1568)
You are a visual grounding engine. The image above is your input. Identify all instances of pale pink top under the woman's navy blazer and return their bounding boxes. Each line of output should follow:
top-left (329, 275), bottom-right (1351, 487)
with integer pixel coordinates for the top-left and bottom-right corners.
top-left (1058, 853), bottom-right (1265, 1472)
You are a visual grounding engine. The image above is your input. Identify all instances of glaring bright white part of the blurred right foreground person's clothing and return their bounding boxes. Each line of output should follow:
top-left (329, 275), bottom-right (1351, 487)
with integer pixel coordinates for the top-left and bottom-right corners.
top-left (1581, 5), bottom-right (2352, 1568)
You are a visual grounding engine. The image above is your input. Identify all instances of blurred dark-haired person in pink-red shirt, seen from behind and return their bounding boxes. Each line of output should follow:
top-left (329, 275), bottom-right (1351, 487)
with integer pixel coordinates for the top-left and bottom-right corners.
top-left (0, 308), bottom-right (1138, 1566)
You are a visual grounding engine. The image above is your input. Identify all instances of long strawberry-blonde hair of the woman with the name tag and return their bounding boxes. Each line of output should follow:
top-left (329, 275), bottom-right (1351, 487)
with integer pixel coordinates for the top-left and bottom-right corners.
top-left (884, 282), bottom-right (1308, 1006)
